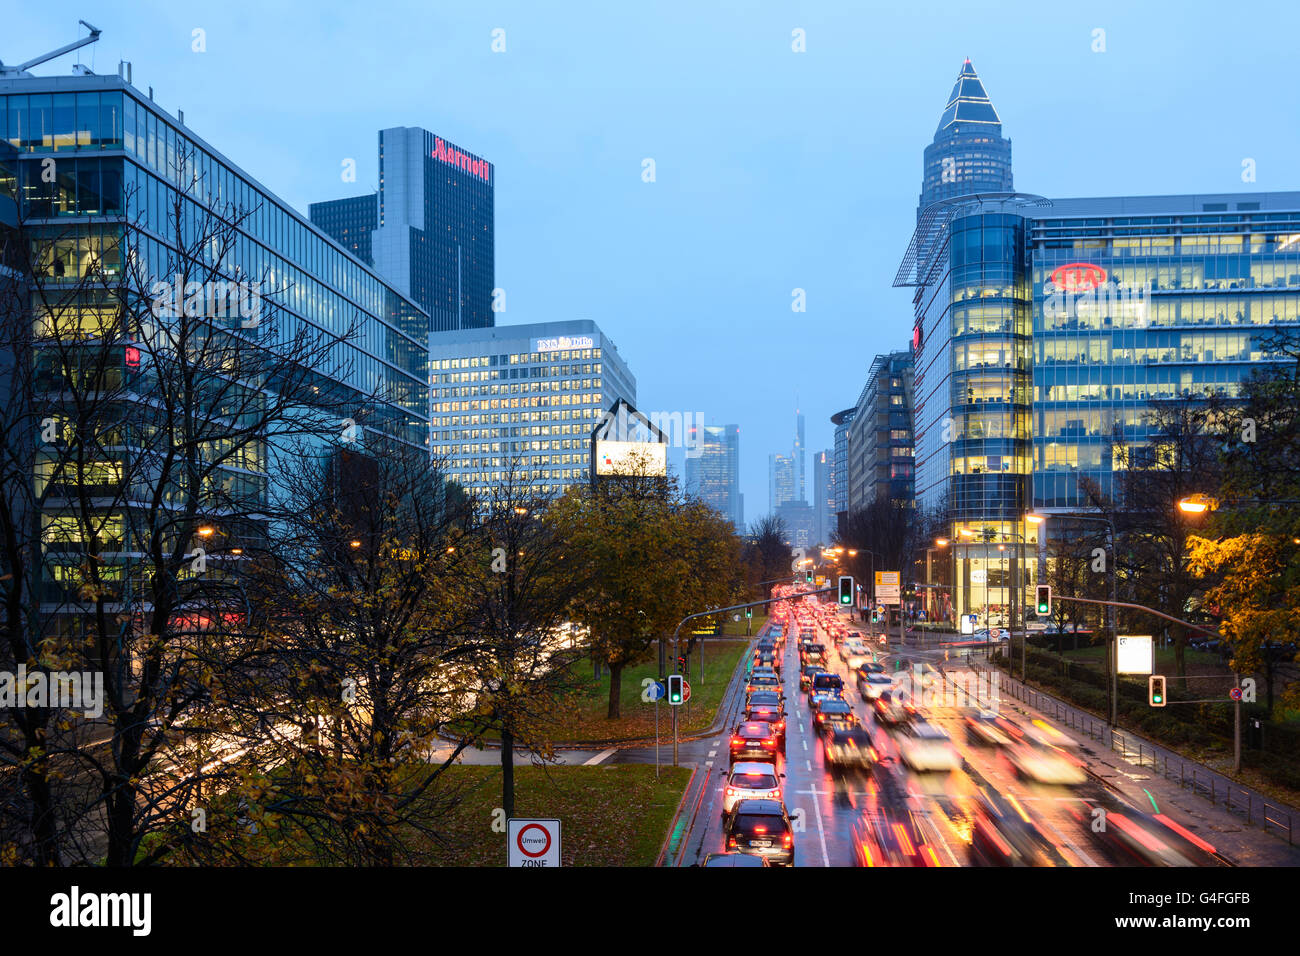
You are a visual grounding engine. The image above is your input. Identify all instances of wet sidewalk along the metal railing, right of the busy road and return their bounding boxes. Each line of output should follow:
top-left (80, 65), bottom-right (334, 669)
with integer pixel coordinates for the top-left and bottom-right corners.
top-left (951, 665), bottom-right (1300, 866)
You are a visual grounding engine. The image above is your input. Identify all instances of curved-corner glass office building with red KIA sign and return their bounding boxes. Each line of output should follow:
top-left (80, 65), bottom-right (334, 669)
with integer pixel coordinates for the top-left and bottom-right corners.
top-left (896, 193), bottom-right (1300, 624)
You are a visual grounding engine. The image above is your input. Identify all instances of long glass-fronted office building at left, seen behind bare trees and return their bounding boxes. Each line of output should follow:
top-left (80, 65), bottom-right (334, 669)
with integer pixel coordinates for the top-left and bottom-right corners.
top-left (0, 65), bottom-right (429, 613)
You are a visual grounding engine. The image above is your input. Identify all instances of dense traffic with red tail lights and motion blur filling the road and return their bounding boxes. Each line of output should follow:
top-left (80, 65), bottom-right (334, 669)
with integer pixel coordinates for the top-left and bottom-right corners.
top-left (688, 585), bottom-right (1223, 866)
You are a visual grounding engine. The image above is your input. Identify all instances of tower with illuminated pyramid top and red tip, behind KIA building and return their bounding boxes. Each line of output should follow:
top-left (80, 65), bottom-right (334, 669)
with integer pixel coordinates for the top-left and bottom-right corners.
top-left (917, 60), bottom-right (1013, 221)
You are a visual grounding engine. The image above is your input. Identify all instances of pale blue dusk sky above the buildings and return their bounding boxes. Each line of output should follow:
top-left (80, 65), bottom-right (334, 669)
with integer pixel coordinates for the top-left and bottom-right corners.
top-left (10, 0), bottom-right (1300, 522)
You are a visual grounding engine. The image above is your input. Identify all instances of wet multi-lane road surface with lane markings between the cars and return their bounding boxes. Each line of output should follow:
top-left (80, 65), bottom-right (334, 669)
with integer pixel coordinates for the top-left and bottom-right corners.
top-left (668, 595), bottom-right (1226, 866)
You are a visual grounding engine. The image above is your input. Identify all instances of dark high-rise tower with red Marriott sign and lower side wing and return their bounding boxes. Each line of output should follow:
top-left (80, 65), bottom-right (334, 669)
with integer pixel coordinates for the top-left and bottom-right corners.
top-left (309, 126), bottom-right (495, 332)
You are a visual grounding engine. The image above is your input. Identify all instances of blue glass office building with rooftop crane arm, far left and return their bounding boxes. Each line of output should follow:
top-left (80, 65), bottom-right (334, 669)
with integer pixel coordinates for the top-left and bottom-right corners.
top-left (0, 74), bottom-right (429, 613)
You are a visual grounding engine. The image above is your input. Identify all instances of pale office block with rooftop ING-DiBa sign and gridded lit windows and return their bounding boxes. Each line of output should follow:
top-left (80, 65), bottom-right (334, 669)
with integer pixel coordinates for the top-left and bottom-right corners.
top-left (429, 319), bottom-right (637, 494)
